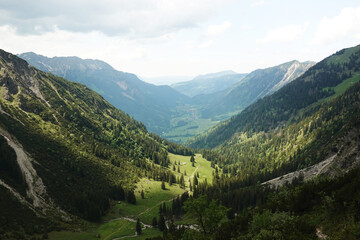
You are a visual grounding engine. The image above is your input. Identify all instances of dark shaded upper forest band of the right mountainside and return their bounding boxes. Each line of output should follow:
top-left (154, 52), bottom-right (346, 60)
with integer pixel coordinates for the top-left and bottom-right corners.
top-left (189, 46), bottom-right (360, 148)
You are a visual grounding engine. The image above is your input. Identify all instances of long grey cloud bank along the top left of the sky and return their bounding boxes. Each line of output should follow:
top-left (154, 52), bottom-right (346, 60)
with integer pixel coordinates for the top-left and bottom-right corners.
top-left (0, 0), bottom-right (228, 38)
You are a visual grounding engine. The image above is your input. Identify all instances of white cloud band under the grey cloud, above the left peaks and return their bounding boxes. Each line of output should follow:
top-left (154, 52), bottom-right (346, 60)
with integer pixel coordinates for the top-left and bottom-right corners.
top-left (0, 25), bottom-right (147, 62)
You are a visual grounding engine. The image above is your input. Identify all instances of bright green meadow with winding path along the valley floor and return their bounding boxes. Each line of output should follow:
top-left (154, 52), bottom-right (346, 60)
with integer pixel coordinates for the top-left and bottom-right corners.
top-left (49, 154), bottom-right (213, 240)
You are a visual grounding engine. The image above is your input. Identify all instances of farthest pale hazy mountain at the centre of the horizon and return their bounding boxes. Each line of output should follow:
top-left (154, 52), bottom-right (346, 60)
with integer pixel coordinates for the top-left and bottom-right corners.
top-left (170, 71), bottom-right (246, 97)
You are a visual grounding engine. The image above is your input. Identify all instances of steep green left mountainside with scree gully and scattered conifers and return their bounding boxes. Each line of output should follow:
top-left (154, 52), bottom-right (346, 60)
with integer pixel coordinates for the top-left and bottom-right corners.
top-left (0, 50), bottom-right (193, 239)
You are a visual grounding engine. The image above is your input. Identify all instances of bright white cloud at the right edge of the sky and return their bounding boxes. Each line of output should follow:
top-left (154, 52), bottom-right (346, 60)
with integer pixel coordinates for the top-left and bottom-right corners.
top-left (309, 7), bottom-right (360, 45)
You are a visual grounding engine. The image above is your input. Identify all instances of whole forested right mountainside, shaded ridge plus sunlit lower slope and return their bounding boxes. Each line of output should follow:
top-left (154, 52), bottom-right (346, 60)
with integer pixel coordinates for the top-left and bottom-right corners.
top-left (189, 46), bottom-right (360, 182)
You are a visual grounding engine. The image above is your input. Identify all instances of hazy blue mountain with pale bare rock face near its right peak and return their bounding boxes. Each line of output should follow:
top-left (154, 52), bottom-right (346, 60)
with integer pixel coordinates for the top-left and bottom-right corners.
top-left (162, 61), bottom-right (313, 142)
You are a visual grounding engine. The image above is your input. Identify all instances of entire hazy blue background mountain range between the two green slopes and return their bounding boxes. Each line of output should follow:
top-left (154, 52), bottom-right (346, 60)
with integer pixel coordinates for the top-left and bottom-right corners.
top-left (19, 53), bottom-right (313, 142)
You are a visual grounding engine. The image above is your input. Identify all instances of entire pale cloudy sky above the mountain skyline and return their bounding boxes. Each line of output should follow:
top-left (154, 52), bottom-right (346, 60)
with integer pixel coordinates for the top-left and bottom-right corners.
top-left (0, 0), bottom-right (360, 82)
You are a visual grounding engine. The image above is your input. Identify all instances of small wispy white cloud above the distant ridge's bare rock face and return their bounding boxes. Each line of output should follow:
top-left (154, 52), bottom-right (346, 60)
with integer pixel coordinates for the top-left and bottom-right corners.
top-left (257, 22), bottom-right (309, 43)
